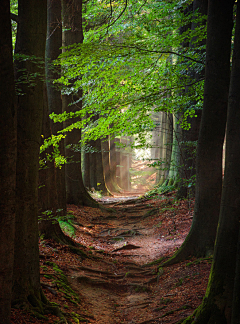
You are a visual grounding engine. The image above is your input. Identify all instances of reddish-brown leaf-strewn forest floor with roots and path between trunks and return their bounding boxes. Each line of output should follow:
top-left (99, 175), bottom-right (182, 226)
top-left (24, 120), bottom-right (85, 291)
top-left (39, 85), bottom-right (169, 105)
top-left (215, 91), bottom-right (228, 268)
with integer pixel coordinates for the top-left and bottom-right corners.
top-left (12, 193), bottom-right (211, 324)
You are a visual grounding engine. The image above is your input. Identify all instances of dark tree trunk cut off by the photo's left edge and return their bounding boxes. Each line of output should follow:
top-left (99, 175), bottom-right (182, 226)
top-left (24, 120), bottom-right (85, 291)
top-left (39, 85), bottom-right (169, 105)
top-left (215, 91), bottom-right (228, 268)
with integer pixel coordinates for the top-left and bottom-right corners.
top-left (0, 0), bottom-right (17, 324)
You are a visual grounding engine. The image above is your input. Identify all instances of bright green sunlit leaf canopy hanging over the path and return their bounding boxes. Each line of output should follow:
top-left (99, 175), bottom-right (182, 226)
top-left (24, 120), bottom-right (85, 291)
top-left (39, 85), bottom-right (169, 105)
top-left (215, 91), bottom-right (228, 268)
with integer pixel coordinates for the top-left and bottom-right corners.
top-left (48, 1), bottom-right (206, 145)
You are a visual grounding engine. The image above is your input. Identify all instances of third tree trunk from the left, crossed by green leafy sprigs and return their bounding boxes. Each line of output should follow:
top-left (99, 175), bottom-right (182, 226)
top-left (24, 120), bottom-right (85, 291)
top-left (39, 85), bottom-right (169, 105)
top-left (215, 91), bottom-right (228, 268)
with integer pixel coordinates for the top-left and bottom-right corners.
top-left (38, 0), bottom-right (69, 243)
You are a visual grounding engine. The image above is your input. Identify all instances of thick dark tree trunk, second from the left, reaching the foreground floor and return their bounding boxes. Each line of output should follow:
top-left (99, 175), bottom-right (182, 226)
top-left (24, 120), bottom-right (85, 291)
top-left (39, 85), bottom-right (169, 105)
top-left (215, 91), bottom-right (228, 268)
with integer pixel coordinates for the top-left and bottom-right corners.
top-left (13, 0), bottom-right (47, 310)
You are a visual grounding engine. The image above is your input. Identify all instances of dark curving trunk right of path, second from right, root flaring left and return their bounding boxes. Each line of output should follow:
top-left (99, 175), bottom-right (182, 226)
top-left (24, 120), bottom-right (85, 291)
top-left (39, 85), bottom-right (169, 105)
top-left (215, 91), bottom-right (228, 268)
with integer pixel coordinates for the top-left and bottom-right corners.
top-left (165, 0), bottom-right (234, 264)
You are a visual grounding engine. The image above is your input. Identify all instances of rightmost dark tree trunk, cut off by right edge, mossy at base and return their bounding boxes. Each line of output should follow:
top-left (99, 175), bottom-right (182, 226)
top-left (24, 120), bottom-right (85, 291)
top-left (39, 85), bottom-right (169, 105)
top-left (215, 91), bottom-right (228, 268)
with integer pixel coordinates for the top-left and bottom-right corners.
top-left (185, 1), bottom-right (240, 324)
